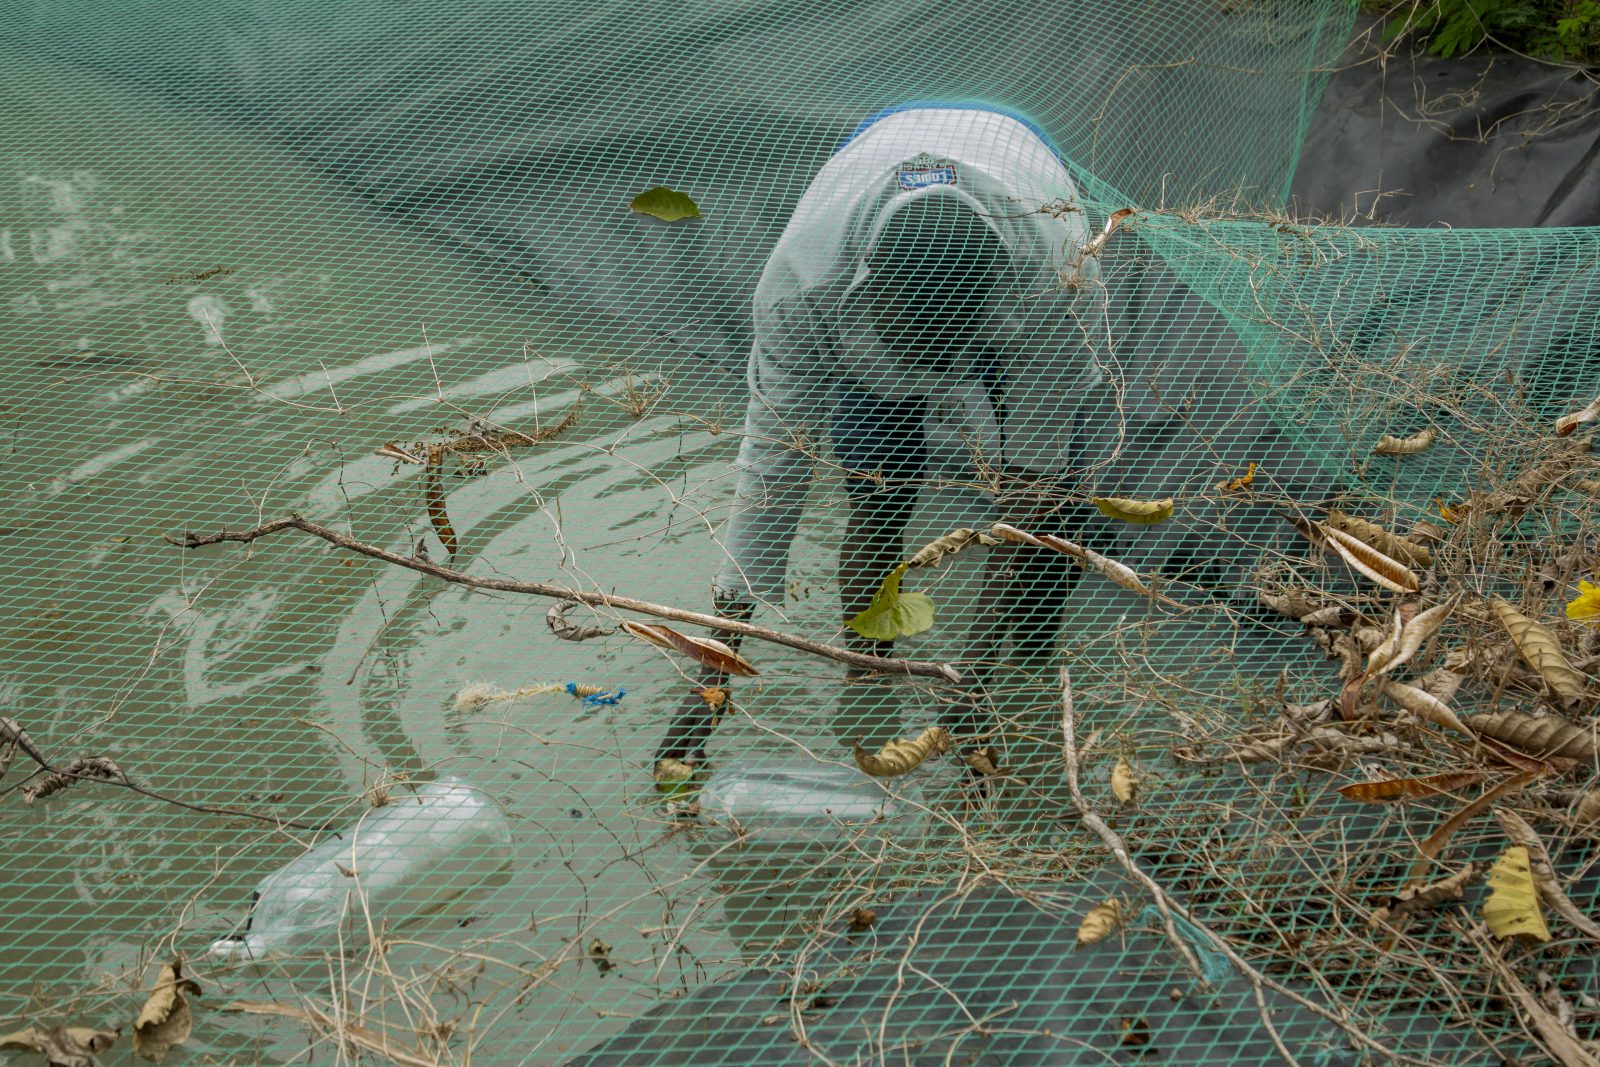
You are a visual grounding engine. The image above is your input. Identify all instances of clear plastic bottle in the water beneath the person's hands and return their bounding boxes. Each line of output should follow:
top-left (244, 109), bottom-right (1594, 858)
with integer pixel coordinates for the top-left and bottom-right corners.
top-left (699, 763), bottom-right (920, 840)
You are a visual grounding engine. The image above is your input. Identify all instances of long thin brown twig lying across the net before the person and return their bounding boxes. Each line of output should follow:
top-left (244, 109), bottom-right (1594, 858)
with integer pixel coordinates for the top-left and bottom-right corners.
top-left (166, 515), bottom-right (962, 685)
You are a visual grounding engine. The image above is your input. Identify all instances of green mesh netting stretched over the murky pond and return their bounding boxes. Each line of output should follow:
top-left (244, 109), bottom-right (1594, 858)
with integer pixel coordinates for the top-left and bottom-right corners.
top-left (0, 2), bottom-right (1600, 1062)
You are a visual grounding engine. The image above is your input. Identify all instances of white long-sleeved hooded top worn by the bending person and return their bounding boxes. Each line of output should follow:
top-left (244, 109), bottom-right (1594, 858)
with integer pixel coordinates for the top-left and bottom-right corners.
top-left (717, 107), bottom-right (1104, 601)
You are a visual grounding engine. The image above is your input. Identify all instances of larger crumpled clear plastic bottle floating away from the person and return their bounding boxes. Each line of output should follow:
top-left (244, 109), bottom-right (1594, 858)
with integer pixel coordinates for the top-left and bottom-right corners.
top-left (211, 777), bottom-right (510, 960)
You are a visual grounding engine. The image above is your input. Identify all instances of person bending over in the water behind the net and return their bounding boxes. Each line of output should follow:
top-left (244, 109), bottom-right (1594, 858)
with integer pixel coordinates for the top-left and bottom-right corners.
top-left (658, 107), bottom-right (1104, 777)
